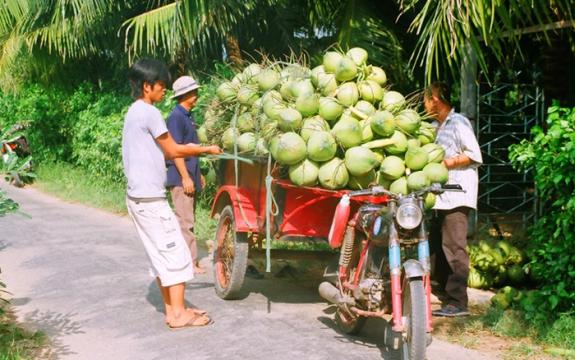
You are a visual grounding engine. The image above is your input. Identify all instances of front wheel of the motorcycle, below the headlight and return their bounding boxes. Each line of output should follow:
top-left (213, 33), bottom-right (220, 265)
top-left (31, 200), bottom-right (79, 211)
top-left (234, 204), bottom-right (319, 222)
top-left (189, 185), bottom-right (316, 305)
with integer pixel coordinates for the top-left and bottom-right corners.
top-left (400, 278), bottom-right (427, 360)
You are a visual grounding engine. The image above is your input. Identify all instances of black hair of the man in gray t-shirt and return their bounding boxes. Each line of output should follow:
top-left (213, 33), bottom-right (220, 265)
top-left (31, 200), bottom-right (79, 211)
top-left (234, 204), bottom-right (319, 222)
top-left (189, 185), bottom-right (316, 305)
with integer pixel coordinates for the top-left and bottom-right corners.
top-left (128, 58), bottom-right (171, 99)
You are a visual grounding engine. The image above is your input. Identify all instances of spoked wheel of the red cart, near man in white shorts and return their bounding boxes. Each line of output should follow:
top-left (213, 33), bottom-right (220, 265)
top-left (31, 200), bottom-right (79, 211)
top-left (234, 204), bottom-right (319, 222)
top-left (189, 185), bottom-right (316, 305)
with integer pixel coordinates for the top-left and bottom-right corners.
top-left (214, 205), bottom-right (248, 300)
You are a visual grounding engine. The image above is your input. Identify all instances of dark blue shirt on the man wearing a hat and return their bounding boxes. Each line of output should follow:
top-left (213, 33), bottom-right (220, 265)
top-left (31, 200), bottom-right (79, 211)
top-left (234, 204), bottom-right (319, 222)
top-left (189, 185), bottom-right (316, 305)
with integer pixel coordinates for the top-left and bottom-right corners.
top-left (166, 104), bottom-right (202, 192)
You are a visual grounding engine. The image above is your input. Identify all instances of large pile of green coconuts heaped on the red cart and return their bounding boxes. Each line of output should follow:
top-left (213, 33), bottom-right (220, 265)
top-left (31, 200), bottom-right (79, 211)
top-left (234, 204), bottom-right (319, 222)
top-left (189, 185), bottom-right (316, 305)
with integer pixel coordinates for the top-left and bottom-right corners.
top-left (198, 47), bottom-right (447, 201)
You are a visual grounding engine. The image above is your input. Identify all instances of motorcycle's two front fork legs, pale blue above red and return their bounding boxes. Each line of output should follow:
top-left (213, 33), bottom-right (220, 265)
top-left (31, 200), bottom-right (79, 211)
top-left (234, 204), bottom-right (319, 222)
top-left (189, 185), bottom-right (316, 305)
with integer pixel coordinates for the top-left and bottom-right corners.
top-left (389, 222), bottom-right (433, 333)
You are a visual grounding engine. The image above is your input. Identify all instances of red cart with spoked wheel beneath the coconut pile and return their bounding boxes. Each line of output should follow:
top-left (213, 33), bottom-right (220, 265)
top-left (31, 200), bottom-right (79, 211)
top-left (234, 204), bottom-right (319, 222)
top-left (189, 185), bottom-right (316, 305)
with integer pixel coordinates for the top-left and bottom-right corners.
top-left (212, 158), bottom-right (386, 299)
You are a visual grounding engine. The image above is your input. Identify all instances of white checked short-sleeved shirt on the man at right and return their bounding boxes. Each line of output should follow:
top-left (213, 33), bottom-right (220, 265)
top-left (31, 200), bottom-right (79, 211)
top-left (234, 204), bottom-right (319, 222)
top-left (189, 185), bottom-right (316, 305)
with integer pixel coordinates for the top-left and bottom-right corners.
top-left (433, 109), bottom-right (483, 210)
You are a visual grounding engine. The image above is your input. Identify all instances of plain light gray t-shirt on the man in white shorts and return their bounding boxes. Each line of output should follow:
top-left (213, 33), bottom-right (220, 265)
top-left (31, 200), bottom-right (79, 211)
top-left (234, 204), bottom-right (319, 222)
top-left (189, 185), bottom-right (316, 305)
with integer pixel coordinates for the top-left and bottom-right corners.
top-left (122, 100), bottom-right (168, 198)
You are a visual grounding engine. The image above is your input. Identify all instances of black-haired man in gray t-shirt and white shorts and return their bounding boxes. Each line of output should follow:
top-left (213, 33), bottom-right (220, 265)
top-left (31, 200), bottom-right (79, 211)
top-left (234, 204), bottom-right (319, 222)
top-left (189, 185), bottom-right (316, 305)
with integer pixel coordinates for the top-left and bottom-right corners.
top-left (122, 59), bottom-right (221, 328)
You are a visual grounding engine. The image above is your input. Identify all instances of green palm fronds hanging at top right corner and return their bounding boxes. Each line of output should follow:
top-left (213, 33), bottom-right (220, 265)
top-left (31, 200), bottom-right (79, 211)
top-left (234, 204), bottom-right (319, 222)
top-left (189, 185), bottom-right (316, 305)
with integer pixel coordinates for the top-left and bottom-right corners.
top-left (400, 0), bottom-right (575, 81)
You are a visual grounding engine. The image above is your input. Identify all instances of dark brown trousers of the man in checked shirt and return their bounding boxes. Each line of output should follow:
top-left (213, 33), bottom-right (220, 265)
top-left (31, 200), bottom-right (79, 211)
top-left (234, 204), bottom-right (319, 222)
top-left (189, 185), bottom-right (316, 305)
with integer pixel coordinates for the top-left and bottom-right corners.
top-left (429, 207), bottom-right (470, 308)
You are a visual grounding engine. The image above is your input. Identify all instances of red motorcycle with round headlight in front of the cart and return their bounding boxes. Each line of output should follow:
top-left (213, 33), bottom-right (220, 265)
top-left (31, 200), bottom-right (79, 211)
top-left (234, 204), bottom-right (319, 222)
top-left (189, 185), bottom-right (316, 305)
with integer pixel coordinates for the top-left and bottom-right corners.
top-left (319, 184), bottom-right (462, 360)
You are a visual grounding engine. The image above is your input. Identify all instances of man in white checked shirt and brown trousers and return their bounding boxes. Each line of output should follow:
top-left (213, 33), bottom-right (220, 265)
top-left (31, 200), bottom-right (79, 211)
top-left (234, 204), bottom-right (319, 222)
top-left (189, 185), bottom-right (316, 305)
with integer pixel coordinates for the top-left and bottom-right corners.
top-left (424, 82), bottom-right (483, 317)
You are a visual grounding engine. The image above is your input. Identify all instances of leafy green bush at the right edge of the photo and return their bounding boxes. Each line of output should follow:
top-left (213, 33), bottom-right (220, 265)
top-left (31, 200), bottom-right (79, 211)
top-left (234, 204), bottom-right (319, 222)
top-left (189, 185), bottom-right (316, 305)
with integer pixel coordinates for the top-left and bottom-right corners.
top-left (510, 106), bottom-right (575, 316)
